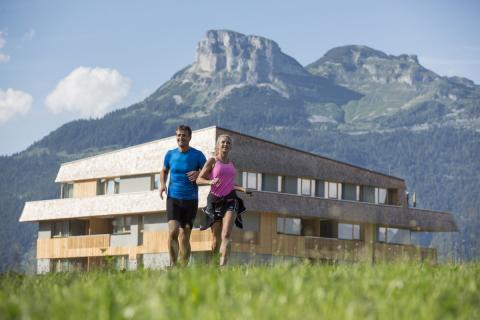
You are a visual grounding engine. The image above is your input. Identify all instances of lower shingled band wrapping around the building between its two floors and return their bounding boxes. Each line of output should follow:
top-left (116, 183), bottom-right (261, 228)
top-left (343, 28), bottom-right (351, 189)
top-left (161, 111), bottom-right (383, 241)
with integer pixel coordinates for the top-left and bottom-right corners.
top-left (20, 187), bottom-right (457, 231)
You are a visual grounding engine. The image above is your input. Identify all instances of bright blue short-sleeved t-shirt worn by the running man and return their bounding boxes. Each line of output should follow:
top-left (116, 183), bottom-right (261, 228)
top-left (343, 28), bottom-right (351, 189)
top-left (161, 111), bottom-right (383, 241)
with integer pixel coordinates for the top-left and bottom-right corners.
top-left (163, 147), bottom-right (207, 200)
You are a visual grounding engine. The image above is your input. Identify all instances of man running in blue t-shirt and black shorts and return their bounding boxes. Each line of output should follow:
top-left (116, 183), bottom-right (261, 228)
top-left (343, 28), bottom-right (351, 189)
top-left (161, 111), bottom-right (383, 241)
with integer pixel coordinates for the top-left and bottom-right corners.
top-left (160, 125), bottom-right (207, 266)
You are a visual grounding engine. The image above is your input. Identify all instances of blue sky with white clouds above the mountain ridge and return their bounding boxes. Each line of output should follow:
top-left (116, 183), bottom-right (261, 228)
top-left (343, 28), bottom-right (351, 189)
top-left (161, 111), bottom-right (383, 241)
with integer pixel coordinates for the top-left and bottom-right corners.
top-left (0, 0), bottom-right (480, 155)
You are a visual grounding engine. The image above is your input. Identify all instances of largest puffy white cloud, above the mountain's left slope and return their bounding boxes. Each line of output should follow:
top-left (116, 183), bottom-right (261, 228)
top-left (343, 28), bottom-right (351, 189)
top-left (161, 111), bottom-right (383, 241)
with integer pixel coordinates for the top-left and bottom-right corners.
top-left (45, 67), bottom-right (131, 118)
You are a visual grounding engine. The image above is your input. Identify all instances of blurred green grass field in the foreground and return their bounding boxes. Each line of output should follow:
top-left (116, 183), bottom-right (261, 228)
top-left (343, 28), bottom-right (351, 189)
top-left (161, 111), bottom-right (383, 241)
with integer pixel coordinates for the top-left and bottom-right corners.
top-left (0, 263), bottom-right (480, 320)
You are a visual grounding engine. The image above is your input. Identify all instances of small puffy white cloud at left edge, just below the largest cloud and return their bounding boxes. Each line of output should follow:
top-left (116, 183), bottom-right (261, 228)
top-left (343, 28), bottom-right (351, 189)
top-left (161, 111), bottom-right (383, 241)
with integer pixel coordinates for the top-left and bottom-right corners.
top-left (0, 88), bottom-right (33, 123)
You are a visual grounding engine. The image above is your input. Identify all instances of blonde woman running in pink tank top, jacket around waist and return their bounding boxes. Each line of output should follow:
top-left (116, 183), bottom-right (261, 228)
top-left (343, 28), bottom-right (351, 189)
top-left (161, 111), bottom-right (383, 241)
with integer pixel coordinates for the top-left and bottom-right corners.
top-left (197, 134), bottom-right (251, 266)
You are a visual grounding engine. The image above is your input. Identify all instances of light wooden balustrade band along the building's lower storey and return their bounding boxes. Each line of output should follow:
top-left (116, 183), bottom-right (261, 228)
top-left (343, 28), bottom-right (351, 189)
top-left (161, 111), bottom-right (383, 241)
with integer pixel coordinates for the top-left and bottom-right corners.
top-left (37, 212), bottom-right (436, 262)
